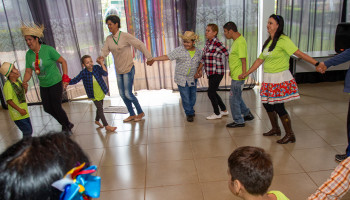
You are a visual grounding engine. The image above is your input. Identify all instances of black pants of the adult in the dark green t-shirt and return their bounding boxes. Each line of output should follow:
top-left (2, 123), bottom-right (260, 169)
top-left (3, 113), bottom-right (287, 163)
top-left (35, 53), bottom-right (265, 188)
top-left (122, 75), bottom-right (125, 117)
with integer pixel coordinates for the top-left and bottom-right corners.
top-left (40, 81), bottom-right (70, 130)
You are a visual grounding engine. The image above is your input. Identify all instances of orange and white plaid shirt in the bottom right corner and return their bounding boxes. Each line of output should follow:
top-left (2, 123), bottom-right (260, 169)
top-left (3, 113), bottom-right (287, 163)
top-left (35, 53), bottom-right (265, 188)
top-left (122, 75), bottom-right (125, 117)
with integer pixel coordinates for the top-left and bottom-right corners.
top-left (308, 157), bottom-right (350, 200)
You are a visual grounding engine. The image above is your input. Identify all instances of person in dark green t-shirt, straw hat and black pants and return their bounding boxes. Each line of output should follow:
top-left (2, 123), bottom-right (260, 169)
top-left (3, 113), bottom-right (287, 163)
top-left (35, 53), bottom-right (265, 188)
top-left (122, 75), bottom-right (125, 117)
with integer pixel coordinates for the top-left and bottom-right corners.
top-left (21, 24), bottom-right (74, 135)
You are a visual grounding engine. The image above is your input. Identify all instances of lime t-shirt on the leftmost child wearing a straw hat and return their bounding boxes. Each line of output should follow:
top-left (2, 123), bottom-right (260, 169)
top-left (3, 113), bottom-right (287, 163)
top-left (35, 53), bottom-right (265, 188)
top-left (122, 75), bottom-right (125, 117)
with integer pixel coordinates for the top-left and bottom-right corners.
top-left (3, 80), bottom-right (29, 121)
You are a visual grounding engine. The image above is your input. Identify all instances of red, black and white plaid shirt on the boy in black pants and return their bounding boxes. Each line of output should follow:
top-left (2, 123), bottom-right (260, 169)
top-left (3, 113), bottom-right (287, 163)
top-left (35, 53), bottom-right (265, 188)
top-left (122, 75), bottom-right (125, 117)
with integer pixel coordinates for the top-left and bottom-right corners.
top-left (201, 37), bottom-right (229, 76)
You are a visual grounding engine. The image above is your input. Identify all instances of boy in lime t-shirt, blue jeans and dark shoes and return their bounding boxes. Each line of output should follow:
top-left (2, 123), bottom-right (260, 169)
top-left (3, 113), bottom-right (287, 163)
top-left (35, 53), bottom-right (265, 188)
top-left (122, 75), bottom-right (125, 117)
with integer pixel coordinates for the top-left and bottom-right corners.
top-left (224, 22), bottom-right (254, 128)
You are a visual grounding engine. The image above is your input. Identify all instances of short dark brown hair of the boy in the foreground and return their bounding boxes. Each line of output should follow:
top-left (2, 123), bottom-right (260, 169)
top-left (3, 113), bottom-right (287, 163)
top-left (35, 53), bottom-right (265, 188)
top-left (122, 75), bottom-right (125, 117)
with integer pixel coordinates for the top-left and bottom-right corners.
top-left (228, 146), bottom-right (273, 195)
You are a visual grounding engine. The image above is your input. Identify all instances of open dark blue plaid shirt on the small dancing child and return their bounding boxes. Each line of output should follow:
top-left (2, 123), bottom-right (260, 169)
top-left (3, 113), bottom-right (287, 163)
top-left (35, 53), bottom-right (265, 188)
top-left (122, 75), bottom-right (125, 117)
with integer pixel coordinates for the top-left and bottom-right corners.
top-left (69, 65), bottom-right (108, 99)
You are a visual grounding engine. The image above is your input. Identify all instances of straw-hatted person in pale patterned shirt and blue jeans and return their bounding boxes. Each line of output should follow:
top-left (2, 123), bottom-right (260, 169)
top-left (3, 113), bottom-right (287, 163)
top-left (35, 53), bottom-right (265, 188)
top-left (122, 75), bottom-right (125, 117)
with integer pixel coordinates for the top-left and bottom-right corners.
top-left (153, 31), bottom-right (202, 122)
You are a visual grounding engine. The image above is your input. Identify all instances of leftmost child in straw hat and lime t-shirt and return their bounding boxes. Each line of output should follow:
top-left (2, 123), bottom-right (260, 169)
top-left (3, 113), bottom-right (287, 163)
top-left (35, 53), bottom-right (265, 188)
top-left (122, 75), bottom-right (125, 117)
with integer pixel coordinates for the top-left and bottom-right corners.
top-left (0, 62), bottom-right (33, 137)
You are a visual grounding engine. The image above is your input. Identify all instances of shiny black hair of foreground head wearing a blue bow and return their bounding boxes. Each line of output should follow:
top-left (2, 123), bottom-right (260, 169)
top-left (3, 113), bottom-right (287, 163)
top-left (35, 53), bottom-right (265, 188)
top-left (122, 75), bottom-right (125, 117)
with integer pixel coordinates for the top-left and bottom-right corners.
top-left (0, 133), bottom-right (90, 200)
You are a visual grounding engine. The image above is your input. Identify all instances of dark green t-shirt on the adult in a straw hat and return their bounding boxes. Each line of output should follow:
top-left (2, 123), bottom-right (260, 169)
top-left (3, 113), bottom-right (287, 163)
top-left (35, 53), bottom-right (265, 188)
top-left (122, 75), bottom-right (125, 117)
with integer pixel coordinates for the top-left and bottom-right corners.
top-left (26, 44), bottom-right (62, 87)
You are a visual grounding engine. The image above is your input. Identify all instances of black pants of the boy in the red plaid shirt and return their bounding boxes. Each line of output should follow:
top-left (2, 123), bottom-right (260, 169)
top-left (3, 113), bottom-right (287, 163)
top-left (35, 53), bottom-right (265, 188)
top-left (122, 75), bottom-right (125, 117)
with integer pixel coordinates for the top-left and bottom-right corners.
top-left (208, 74), bottom-right (226, 115)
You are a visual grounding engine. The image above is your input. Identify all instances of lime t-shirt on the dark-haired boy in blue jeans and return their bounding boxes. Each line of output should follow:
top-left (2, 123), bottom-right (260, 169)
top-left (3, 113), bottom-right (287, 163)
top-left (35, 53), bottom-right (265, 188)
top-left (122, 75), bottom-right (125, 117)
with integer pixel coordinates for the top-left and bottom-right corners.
top-left (228, 35), bottom-right (249, 81)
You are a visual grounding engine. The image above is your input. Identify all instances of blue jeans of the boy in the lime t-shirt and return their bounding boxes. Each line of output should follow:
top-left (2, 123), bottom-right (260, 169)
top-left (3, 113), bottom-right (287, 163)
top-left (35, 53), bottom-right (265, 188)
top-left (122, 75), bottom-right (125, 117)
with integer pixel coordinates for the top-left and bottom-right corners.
top-left (229, 80), bottom-right (249, 124)
